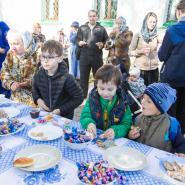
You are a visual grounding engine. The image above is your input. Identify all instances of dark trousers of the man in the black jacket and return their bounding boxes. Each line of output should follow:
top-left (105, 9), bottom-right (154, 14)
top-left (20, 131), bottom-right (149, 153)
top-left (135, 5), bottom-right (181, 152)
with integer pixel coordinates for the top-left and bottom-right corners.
top-left (80, 54), bottom-right (103, 98)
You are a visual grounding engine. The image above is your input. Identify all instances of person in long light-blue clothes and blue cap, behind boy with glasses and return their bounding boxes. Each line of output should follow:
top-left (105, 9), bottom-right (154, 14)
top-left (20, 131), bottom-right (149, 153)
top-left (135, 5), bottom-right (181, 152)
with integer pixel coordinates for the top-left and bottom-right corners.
top-left (69, 21), bottom-right (80, 80)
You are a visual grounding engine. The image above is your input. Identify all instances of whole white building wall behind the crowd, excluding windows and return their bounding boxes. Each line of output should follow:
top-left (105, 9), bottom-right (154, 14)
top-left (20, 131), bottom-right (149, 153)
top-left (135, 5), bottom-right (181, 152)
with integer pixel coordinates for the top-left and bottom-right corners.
top-left (0, 0), bottom-right (169, 39)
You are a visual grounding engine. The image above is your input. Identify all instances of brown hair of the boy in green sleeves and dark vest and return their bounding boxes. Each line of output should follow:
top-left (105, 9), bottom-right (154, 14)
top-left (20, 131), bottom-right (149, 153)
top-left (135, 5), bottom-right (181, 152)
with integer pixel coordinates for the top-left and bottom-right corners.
top-left (95, 64), bottom-right (121, 86)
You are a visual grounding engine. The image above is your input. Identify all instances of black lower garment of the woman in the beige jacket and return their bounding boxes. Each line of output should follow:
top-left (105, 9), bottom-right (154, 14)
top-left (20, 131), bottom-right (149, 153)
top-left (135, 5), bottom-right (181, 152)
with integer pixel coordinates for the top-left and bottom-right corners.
top-left (140, 68), bottom-right (159, 86)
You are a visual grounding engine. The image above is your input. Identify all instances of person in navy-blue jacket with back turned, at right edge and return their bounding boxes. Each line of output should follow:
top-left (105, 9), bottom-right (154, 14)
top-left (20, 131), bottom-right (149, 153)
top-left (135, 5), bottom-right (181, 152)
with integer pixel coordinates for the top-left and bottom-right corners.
top-left (158, 0), bottom-right (185, 134)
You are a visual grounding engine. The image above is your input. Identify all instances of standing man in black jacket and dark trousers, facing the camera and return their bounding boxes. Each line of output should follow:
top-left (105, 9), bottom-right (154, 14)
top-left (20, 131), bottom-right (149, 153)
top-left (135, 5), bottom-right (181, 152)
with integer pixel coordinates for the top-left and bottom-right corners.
top-left (77, 10), bottom-right (108, 98)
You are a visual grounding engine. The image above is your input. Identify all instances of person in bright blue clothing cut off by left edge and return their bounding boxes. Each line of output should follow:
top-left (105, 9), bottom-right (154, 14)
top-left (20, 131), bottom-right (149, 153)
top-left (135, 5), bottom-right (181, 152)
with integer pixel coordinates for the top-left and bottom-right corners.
top-left (0, 21), bottom-right (10, 98)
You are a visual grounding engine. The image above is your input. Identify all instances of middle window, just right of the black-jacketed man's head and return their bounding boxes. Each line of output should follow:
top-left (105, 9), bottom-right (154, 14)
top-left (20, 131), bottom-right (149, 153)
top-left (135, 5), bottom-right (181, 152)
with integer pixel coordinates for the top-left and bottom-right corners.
top-left (96, 0), bottom-right (117, 20)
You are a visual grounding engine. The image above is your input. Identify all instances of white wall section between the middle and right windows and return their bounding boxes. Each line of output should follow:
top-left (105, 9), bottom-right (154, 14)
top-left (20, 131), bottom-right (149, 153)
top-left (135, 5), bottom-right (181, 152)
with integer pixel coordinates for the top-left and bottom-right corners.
top-left (118, 0), bottom-right (169, 32)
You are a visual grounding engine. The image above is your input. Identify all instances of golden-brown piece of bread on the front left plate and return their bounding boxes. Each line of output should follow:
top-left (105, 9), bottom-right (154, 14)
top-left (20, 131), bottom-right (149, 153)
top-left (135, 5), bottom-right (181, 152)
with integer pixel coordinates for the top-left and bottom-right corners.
top-left (13, 157), bottom-right (34, 168)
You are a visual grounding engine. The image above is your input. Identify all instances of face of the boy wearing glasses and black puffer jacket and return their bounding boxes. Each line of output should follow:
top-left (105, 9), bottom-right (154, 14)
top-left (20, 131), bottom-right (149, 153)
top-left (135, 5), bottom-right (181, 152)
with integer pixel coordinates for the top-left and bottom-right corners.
top-left (41, 52), bottom-right (62, 73)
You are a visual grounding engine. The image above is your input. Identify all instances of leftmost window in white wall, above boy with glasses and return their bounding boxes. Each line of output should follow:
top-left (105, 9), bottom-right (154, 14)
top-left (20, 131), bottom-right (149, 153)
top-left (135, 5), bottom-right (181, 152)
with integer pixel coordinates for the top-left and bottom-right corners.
top-left (41, 0), bottom-right (59, 23)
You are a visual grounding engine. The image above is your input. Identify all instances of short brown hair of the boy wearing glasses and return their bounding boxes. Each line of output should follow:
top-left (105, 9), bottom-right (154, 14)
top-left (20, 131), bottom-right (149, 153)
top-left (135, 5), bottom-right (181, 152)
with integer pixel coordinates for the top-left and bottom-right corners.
top-left (41, 40), bottom-right (63, 56)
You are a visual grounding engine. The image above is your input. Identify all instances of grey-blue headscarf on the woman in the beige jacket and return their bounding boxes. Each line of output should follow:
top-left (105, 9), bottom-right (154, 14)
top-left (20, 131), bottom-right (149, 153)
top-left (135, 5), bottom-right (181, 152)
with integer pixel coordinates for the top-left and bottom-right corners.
top-left (141, 12), bottom-right (157, 43)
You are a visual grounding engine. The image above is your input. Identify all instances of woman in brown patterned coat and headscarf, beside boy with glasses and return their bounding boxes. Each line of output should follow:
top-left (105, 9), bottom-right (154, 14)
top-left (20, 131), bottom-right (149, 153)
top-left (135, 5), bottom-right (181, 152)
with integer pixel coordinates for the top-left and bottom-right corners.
top-left (1, 30), bottom-right (38, 106)
